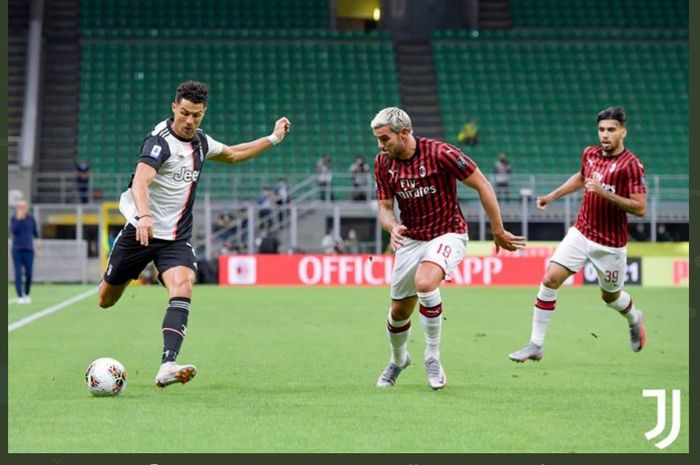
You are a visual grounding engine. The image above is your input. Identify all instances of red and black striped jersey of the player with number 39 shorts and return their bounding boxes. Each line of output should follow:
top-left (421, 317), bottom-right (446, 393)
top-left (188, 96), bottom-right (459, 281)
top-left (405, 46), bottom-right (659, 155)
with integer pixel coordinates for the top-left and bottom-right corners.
top-left (574, 146), bottom-right (647, 247)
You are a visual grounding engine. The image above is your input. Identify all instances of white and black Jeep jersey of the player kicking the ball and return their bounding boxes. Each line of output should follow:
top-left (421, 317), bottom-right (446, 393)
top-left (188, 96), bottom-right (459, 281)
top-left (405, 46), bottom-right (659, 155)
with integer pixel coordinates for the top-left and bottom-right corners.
top-left (119, 118), bottom-right (224, 241)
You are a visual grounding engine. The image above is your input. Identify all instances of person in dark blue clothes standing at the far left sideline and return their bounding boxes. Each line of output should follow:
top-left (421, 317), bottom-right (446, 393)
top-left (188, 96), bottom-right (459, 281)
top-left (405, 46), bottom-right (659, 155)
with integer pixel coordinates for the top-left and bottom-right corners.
top-left (10, 200), bottom-right (40, 304)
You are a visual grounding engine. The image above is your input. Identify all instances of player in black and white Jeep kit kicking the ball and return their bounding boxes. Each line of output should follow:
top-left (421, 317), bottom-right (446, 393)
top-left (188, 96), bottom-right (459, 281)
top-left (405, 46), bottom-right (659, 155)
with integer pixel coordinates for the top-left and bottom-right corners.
top-left (99, 81), bottom-right (291, 387)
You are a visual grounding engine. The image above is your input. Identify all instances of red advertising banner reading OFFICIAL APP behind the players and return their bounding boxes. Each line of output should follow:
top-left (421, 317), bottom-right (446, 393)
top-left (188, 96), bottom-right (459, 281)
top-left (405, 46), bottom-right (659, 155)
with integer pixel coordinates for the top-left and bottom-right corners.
top-left (219, 255), bottom-right (583, 286)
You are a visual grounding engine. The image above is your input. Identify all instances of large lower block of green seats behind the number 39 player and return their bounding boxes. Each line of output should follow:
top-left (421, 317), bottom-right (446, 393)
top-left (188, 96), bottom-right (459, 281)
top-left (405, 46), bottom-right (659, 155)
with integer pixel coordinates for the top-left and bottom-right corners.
top-left (433, 30), bottom-right (689, 181)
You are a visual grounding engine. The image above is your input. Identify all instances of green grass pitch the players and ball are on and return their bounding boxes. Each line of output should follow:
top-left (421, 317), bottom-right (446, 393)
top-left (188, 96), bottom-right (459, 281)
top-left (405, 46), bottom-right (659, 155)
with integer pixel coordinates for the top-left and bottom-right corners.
top-left (8, 286), bottom-right (689, 453)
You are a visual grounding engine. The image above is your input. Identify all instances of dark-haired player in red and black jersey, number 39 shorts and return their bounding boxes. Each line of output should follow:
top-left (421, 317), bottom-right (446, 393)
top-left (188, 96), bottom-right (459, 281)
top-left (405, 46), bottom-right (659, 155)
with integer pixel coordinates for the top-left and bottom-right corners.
top-left (508, 107), bottom-right (647, 362)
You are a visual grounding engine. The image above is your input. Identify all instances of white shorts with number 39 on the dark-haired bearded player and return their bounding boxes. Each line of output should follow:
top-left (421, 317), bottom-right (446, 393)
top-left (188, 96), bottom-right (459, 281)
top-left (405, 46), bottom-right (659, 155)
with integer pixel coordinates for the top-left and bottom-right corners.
top-left (550, 226), bottom-right (627, 292)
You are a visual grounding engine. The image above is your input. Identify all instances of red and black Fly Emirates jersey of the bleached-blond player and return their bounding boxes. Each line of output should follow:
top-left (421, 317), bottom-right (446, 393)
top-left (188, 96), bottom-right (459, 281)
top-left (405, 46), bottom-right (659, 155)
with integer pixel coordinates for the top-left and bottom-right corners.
top-left (374, 137), bottom-right (477, 241)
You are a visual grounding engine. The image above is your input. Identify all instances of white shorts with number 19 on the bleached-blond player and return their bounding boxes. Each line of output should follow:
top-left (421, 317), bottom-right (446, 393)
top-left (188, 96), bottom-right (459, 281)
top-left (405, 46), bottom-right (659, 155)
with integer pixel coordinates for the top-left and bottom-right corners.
top-left (391, 233), bottom-right (469, 300)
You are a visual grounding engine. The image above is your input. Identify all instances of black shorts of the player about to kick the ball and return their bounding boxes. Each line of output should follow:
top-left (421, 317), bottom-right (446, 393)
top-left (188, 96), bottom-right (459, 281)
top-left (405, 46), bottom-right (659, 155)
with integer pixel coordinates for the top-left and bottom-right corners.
top-left (103, 224), bottom-right (197, 286)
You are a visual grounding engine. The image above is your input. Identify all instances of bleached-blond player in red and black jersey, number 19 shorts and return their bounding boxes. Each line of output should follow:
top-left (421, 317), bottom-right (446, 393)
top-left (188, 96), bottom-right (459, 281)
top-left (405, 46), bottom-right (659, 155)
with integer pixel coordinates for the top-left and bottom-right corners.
top-left (371, 107), bottom-right (525, 389)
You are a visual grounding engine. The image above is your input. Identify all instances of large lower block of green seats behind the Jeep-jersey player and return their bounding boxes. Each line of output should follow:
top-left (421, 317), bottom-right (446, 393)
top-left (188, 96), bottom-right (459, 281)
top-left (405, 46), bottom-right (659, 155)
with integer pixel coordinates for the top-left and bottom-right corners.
top-left (79, 31), bottom-right (399, 198)
